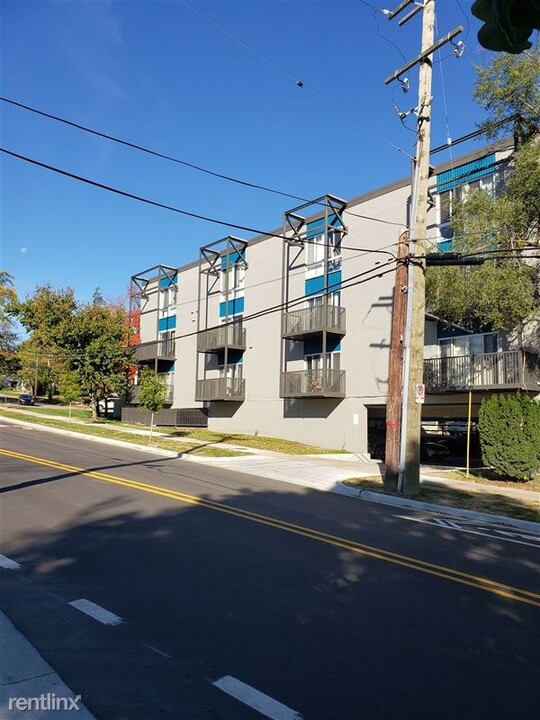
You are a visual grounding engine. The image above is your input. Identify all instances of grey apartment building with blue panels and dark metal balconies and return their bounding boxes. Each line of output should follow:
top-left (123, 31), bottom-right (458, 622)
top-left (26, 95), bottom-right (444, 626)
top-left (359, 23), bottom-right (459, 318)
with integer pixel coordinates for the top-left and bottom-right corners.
top-left (126, 142), bottom-right (540, 453)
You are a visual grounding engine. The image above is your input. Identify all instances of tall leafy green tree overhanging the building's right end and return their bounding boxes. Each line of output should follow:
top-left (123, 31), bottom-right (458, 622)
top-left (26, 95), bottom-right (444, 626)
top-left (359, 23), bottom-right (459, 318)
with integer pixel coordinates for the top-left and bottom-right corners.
top-left (426, 50), bottom-right (540, 330)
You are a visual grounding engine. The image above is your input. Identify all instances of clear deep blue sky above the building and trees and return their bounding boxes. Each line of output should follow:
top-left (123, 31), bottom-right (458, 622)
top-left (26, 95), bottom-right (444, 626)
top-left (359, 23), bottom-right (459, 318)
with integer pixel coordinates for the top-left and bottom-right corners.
top-left (0, 0), bottom-right (498, 300)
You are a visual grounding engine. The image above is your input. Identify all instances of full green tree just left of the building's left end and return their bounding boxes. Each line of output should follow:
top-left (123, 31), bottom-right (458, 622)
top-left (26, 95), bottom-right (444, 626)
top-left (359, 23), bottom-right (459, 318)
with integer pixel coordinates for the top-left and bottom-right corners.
top-left (55, 304), bottom-right (133, 419)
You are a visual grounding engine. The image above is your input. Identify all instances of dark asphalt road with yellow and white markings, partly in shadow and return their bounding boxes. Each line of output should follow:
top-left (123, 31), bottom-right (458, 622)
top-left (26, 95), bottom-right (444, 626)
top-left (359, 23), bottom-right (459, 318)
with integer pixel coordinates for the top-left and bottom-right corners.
top-left (0, 425), bottom-right (540, 720)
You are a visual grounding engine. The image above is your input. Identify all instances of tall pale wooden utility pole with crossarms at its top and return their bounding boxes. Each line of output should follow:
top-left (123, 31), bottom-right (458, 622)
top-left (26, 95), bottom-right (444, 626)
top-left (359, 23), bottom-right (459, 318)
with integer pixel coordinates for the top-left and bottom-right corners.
top-left (385, 0), bottom-right (463, 495)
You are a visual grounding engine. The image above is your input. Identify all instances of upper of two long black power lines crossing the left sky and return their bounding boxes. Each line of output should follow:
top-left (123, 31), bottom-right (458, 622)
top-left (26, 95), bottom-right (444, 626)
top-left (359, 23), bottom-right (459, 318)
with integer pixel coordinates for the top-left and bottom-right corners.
top-left (0, 96), bottom-right (401, 226)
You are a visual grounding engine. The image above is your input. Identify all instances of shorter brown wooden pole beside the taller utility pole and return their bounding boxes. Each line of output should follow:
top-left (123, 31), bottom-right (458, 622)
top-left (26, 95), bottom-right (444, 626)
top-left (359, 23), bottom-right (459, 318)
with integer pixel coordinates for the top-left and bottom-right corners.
top-left (384, 230), bottom-right (409, 492)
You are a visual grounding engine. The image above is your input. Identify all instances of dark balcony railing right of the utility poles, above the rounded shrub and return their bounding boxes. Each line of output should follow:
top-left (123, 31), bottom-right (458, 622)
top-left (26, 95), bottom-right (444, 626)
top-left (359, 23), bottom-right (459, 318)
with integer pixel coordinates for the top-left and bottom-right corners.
top-left (424, 350), bottom-right (536, 393)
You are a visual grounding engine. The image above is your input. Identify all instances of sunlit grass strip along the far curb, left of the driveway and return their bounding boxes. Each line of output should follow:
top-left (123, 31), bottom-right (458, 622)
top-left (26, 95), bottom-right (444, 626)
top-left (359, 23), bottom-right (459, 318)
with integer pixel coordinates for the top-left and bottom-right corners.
top-left (0, 408), bottom-right (244, 457)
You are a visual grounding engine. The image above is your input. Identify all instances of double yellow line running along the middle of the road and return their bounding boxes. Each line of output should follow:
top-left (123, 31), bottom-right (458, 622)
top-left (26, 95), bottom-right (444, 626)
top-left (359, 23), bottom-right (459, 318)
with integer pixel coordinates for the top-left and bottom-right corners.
top-left (0, 449), bottom-right (540, 607)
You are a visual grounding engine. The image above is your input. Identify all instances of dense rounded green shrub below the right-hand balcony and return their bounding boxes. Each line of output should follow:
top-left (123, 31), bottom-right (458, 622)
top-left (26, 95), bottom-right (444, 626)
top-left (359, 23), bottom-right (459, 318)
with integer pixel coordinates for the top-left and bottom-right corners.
top-left (478, 392), bottom-right (540, 480)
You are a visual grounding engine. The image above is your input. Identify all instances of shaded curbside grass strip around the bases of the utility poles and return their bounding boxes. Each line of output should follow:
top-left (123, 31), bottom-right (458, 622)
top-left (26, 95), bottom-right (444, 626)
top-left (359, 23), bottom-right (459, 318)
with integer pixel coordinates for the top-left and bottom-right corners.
top-left (344, 476), bottom-right (540, 522)
